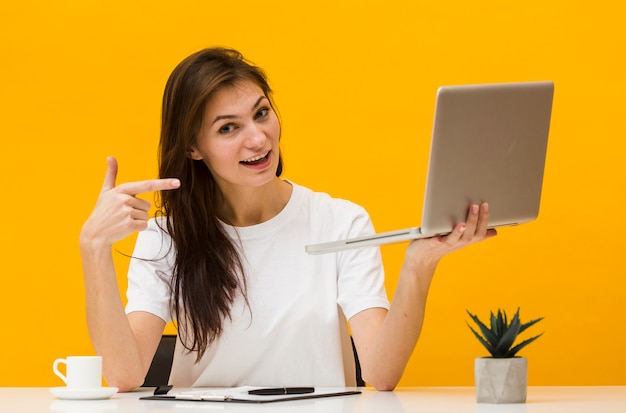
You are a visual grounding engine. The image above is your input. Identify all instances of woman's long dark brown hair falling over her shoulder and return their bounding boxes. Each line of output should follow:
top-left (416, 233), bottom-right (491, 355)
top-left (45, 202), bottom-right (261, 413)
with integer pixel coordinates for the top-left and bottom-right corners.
top-left (157, 48), bottom-right (282, 360)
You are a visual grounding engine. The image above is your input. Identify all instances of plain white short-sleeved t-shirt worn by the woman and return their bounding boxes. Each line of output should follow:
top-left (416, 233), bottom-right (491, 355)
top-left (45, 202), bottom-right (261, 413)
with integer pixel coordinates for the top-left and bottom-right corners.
top-left (126, 183), bottom-right (389, 387)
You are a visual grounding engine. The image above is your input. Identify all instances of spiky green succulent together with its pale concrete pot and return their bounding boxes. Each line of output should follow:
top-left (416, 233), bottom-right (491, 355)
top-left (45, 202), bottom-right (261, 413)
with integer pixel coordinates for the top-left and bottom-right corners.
top-left (467, 308), bottom-right (543, 403)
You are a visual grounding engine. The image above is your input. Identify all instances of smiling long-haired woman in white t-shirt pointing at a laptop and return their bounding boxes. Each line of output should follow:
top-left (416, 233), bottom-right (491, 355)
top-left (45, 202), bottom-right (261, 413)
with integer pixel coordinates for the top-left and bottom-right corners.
top-left (80, 48), bottom-right (495, 391)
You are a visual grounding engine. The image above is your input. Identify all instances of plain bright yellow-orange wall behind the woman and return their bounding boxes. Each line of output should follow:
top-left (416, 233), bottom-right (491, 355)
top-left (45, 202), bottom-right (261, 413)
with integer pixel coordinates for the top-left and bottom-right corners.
top-left (0, 0), bottom-right (626, 386)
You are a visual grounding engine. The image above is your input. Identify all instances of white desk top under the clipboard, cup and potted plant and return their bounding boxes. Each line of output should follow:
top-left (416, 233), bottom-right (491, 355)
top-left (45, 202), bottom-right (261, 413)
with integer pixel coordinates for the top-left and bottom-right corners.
top-left (0, 386), bottom-right (626, 413)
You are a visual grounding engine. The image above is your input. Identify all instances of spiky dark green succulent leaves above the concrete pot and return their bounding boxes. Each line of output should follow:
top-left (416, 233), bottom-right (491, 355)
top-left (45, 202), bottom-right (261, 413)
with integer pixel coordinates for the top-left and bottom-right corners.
top-left (467, 308), bottom-right (543, 358)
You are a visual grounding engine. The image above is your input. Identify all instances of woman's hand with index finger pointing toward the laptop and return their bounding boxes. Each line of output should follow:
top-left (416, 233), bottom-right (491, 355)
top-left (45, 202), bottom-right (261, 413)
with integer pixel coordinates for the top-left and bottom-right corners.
top-left (80, 157), bottom-right (180, 247)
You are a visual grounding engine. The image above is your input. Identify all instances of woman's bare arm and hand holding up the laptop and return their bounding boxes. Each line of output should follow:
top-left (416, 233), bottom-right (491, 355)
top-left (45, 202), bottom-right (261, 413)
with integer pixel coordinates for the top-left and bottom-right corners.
top-left (350, 204), bottom-right (496, 390)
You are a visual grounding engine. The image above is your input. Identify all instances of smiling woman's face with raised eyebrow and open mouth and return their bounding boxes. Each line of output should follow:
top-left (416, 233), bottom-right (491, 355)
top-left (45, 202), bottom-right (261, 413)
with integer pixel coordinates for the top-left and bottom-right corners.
top-left (191, 81), bottom-right (280, 191)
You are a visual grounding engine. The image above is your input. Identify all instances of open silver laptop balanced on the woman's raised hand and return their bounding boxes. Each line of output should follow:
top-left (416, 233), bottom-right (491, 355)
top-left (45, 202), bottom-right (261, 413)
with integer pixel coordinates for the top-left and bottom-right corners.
top-left (305, 81), bottom-right (554, 254)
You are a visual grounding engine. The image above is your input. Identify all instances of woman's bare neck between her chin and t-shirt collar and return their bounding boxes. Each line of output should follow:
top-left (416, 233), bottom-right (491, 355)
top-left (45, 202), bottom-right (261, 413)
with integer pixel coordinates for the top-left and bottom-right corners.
top-left (216, 178), bottom-right (293, 227)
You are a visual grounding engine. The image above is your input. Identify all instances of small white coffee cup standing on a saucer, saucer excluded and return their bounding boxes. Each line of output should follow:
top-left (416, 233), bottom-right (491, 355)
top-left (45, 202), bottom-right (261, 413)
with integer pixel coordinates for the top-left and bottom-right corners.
top-left (52, 356), bottom-right (102, 389)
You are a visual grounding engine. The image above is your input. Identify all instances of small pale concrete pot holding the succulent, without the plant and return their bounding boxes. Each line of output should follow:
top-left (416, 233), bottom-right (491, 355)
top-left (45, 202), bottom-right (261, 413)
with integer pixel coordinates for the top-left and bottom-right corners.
top-left (474, 357), bottom-right (528, 403)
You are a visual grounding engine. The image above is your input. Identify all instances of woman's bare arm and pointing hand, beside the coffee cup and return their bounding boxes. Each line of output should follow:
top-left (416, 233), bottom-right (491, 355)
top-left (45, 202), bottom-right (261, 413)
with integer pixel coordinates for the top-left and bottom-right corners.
top-left (80, 158), bottom-right (180, 391)
